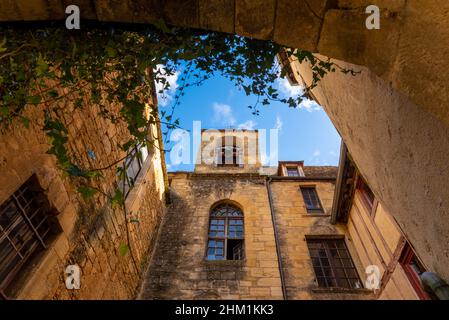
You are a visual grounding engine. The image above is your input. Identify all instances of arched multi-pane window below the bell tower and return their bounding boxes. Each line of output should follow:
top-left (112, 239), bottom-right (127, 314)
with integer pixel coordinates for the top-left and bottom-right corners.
top-left (207, 203), bottom-right (244, 260)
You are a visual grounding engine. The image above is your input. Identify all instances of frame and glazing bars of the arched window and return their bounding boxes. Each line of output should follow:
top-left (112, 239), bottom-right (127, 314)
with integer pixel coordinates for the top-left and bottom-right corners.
top-left (205, 203), bottom-right (246, 261)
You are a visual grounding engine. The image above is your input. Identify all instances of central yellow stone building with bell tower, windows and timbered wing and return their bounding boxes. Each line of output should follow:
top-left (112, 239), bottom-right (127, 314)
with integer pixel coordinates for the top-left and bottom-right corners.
top-left (140, 130), bottom-right (428, 299)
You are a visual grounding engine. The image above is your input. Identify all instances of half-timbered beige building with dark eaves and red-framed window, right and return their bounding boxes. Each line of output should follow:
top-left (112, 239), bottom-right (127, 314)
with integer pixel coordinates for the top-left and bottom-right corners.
top-left (331, 145), bottom-right (430, 300)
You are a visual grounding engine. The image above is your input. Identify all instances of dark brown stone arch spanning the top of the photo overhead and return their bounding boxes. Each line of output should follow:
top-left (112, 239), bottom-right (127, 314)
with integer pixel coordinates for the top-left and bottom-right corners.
top-left (0, 0), bottom-right (449, 126)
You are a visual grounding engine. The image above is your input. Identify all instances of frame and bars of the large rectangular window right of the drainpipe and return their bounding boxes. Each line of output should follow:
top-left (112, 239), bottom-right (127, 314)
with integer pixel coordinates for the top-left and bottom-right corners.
top-left (306, 237), bottom-right (363, 290)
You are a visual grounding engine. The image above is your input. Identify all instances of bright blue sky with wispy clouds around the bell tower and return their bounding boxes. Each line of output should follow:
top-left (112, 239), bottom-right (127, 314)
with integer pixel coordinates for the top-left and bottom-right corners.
top-left (159, 69), bottom-right (340, 171)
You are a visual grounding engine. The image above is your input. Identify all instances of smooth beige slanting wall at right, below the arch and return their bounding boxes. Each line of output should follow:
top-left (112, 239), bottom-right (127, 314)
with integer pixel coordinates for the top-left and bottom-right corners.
top-left (292, 56), bottom-right (449, 280)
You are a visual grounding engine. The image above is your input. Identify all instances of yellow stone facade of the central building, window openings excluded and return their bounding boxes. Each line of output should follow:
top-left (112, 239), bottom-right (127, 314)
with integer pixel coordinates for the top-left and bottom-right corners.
top-left (139, 130), bottom-right (428, 300)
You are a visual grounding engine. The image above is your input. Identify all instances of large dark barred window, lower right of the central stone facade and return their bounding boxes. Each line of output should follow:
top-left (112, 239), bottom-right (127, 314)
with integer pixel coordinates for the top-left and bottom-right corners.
top-left (307, 239), bottom-right (362, 289)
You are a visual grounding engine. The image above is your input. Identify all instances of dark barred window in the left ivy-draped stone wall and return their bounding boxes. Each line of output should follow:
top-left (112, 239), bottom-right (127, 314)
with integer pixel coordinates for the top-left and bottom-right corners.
top-left (0, 175), bottom-right (60, 298)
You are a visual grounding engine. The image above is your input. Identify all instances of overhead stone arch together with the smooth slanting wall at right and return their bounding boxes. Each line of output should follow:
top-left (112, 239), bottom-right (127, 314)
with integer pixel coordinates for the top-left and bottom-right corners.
top-left (0, 0), bottom-right (449, 296)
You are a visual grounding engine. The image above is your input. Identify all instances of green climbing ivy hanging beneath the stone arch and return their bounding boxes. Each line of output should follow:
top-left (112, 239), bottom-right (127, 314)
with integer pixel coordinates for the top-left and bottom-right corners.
top-left (0, 23), bottom-right (354, 258)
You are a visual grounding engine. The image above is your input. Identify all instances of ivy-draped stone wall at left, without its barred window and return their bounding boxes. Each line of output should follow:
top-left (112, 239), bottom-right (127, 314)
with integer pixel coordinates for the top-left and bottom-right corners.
top-left (0, 84), bottom-right (165, 299)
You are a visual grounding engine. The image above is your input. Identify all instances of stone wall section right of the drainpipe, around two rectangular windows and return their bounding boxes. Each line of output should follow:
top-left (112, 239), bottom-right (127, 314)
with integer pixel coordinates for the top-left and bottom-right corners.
top-left (271, 179), bottom-right (373, 300)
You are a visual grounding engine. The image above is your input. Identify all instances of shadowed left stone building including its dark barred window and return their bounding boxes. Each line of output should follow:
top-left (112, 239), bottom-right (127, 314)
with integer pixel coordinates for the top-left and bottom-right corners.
top-left (0, 81), bottom-right (168, 299)
